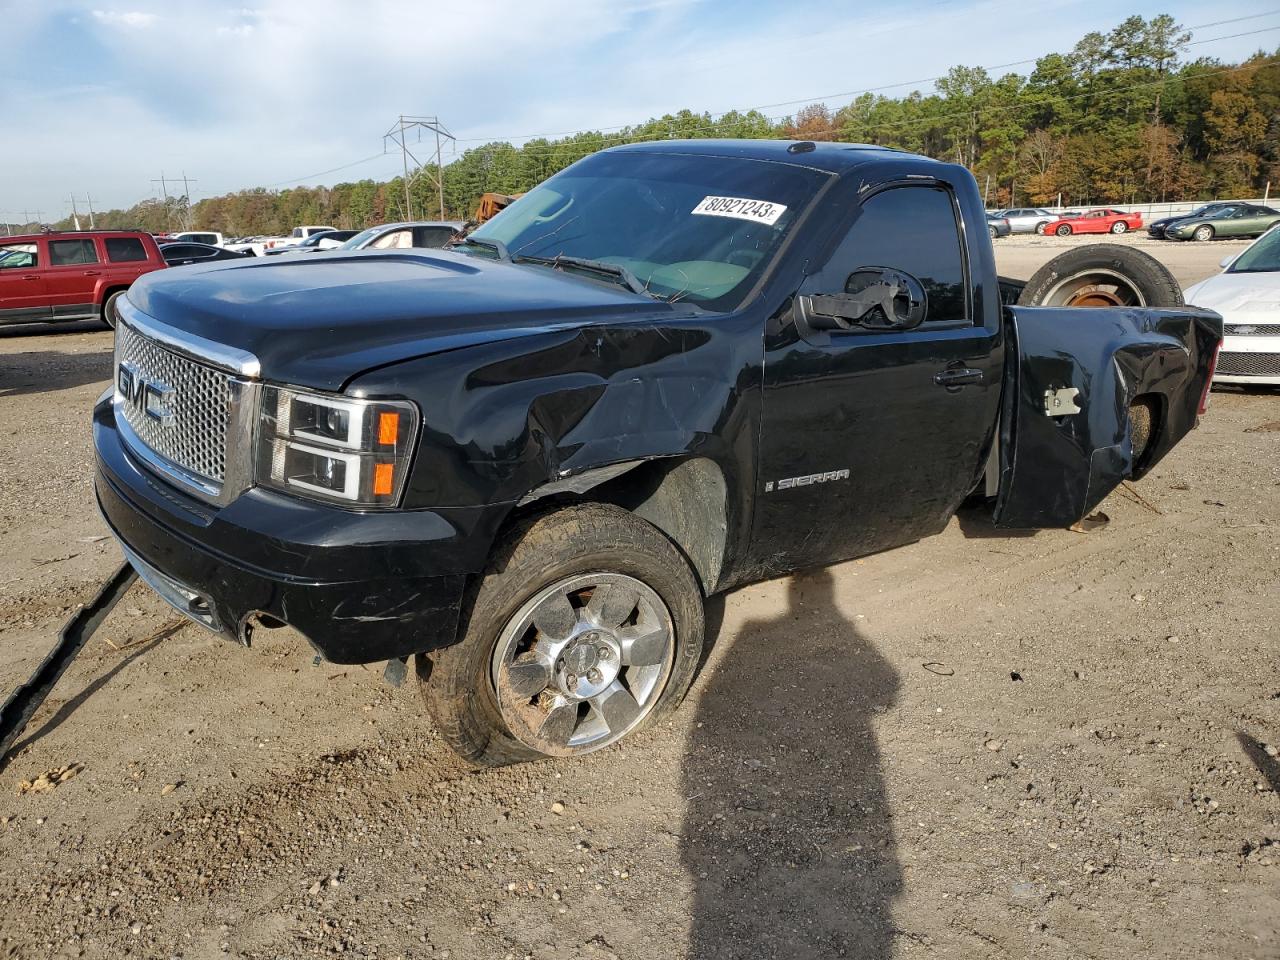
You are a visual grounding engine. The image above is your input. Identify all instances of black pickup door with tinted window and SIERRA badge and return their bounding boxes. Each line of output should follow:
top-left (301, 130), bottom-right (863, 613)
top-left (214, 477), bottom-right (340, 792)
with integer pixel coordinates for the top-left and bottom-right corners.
top-left (753, 180), bottom-right (1002, 572)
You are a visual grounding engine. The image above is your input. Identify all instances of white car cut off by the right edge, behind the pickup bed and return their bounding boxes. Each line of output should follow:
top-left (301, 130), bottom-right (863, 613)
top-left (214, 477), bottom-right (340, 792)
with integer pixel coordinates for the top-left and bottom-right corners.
top-left (1183, 224), bottom-right (1280, 387)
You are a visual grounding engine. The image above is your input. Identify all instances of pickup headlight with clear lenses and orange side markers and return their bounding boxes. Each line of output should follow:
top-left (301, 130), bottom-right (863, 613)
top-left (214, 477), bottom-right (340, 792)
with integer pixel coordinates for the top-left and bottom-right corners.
top-left (257, 387), bottom-right (417, 507)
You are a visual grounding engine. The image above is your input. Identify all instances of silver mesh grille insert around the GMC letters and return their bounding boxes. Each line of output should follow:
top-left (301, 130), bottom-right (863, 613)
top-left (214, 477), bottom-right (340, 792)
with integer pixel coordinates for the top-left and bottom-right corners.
top-left (115, 324), bottom-right (232, 484)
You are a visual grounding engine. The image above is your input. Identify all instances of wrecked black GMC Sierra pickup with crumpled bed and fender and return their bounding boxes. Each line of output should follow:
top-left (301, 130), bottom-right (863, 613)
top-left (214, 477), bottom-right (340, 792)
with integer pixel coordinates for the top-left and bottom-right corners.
top-left (93, 141), bottom-right (1222, 763)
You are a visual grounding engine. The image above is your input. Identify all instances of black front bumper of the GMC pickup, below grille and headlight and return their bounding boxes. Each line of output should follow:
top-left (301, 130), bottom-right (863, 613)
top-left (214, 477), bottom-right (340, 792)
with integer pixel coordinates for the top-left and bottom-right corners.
top-left (93, 397), bottom-right (511, 663)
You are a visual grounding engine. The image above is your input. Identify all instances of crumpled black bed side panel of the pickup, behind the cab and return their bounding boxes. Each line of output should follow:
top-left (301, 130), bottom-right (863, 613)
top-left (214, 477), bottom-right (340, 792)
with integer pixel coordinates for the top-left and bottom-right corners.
top-left (995, 307), bottom-right (1222, 527)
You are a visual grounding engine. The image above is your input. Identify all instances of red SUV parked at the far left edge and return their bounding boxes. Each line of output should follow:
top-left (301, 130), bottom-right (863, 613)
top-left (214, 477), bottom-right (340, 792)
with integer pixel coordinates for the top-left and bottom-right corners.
top-left (0, 230), bottom-right (165, 325)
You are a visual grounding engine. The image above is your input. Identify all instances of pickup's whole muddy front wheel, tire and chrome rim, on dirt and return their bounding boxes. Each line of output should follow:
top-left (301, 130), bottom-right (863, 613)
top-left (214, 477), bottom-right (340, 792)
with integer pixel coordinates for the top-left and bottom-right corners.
top-left (416, 504), bottom-right (704, 767)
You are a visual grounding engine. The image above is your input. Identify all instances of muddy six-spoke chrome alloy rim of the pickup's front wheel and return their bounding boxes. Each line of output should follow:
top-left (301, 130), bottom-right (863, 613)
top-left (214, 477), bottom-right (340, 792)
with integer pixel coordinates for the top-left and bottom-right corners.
top-left (489, 573), bottom-right (676, 756)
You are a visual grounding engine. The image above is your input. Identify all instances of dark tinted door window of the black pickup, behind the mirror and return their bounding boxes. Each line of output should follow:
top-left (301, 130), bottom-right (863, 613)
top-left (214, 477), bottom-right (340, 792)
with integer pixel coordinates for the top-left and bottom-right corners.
top-left (818, 186), bottom-right (967, 325)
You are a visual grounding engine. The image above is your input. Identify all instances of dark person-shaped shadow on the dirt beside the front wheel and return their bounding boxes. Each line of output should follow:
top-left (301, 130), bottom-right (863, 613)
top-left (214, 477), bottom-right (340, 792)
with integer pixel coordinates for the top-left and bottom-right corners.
top-left (680, 570), bottom-right (902, 960)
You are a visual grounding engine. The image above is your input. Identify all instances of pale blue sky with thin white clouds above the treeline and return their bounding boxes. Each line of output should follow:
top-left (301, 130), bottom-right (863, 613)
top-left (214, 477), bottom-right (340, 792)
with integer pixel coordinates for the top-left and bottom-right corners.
top-left (0, 0), bottom-right (1280, 221)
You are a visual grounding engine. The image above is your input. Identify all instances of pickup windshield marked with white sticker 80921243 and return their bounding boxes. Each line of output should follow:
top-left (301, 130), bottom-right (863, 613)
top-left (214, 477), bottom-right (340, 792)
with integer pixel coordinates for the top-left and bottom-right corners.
top-left (457, 151), bottom-right (828, 310)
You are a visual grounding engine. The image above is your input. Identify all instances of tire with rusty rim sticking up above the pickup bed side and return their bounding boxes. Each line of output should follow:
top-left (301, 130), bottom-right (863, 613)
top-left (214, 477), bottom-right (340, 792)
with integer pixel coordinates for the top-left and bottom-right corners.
top-left (1018, 243), bottom-right (1183, 307)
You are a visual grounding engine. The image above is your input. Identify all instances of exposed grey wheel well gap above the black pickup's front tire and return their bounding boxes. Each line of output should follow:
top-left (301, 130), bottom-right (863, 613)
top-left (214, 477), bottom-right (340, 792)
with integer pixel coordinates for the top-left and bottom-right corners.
top-left (498, 457), bottom-right (728, 594)
